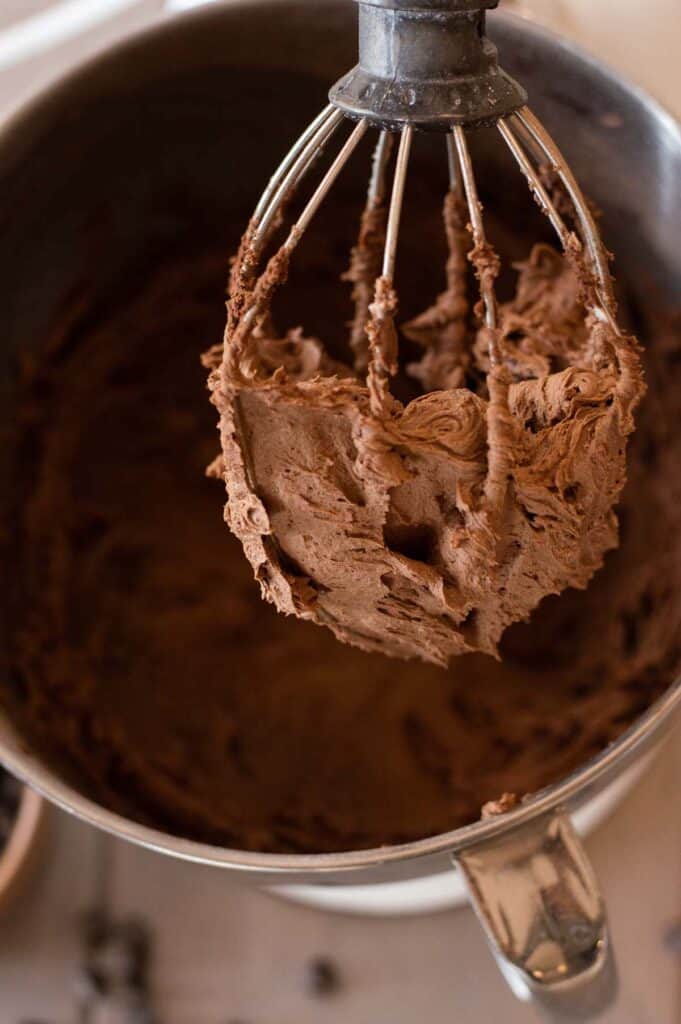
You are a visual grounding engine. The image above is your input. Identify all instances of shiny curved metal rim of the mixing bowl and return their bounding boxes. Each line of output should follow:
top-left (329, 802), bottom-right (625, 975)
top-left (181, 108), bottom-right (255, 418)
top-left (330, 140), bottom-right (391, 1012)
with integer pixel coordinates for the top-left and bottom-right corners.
top-left (0, 0), bottom-right (681, 881)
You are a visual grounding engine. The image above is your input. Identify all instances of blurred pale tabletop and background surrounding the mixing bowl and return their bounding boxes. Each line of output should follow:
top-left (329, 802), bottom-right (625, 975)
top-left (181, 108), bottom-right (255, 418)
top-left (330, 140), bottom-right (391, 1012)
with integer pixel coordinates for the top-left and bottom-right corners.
top-left (0, 0), bottom-right (681, 1024)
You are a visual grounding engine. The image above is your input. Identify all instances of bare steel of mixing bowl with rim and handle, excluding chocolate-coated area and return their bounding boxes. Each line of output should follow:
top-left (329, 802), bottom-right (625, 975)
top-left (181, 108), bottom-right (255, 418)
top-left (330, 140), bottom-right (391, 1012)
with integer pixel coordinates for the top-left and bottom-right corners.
top-left (0, 6), bottom-right (681, 1019)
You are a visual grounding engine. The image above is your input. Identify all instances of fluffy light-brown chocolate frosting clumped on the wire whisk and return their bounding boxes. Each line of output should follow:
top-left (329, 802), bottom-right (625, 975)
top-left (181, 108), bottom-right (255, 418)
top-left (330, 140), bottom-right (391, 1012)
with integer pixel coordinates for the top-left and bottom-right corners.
top-left (206, 201), bottom-right (643, 665)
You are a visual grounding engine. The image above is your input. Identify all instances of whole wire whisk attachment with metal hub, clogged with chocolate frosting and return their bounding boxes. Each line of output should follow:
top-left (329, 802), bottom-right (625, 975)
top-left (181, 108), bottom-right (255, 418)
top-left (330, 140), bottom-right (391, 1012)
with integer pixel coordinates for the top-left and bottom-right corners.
top-left (206, 0), bottom-right (643, 665)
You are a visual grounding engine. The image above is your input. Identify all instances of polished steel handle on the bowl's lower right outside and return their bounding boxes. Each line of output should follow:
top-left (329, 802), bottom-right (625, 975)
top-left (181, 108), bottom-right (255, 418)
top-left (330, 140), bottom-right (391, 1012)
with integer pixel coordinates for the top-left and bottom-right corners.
top-left (456, 813), bottom-right (618, 1024)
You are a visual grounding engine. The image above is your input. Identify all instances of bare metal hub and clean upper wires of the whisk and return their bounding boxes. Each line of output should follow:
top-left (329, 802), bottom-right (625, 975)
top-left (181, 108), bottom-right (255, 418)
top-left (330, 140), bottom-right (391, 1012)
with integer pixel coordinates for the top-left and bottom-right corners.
top-left (235, 0), bottom-right (618, 367)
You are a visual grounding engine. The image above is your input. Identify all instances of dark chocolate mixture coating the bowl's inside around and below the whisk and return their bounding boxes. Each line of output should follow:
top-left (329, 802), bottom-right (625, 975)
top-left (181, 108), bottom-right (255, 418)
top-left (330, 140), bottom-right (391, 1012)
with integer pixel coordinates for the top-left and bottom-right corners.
top-left (3, 241), bottom-right (681, 852)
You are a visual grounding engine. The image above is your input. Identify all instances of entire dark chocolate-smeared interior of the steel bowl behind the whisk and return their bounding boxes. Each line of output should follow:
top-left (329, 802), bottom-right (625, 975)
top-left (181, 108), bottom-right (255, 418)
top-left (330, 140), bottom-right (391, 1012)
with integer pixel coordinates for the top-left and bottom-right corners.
top-left (0, 2), bottom-right (681, 868)
